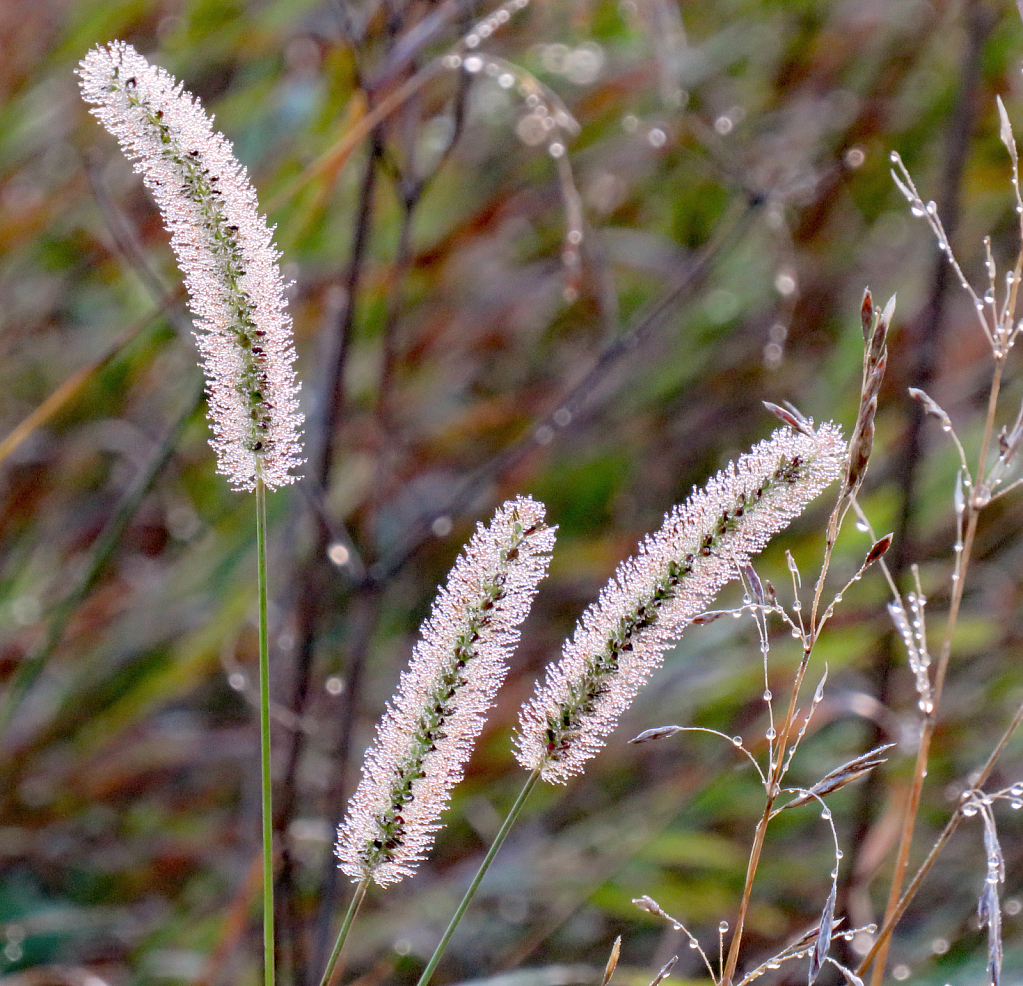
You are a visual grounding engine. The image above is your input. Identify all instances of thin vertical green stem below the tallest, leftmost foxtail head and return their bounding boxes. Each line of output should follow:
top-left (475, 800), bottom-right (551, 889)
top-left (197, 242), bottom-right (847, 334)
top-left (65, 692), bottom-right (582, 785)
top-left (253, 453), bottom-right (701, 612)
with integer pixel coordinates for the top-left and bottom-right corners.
top-left (256, 478), bottom-right (274, 986)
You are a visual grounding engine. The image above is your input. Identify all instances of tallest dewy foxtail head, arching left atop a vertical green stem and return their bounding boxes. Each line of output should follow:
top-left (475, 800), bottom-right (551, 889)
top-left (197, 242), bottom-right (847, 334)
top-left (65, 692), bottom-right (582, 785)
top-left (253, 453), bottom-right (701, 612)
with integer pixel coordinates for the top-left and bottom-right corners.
top-left (78, 41), bottom-right (304, 490)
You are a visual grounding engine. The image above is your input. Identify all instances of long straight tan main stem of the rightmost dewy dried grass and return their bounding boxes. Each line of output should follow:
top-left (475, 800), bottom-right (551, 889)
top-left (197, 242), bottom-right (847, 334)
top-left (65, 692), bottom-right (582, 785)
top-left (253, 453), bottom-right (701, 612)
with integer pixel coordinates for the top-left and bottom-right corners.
top-left (871, 359), bottom-right (1004, 986)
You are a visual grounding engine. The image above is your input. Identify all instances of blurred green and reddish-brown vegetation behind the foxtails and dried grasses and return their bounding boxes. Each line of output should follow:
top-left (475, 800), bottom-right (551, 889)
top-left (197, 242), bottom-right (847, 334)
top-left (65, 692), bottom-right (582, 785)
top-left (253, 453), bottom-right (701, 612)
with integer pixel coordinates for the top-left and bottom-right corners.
top-left (0, 0), bottom-right (1023, 986)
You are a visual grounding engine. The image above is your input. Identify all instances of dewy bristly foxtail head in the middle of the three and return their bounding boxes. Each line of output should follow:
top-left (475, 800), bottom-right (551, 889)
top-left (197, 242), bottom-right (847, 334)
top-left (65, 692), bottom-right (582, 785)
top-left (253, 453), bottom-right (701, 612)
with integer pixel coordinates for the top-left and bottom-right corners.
top-left (337, 497), bottom-right (554, 886)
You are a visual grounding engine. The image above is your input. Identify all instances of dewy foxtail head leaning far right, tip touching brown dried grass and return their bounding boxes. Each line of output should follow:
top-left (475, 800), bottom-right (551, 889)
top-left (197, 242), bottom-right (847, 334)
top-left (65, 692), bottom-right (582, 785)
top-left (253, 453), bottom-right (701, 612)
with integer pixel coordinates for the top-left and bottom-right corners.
top-left (516, 423), bottom-right (846, 783)
